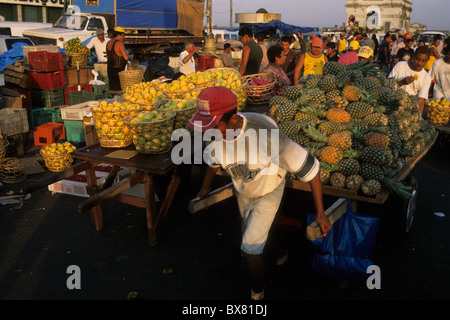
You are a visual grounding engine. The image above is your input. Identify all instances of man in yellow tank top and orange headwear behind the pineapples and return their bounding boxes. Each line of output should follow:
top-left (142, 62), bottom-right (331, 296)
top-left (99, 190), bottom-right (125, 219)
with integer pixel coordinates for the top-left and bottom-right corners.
top-left (294, 37), bottom-right (328, 85)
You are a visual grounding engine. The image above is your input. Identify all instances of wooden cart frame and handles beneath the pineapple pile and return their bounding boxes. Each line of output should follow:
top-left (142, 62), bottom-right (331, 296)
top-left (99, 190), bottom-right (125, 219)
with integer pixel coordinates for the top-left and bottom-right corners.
top-left (189, 132), bottom-right (438, 240)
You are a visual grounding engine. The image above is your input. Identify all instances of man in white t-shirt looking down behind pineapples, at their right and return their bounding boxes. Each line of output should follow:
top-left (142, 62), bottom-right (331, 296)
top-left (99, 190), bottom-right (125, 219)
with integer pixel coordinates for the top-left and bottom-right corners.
top-left (389, 47), bottom-right (431, 113)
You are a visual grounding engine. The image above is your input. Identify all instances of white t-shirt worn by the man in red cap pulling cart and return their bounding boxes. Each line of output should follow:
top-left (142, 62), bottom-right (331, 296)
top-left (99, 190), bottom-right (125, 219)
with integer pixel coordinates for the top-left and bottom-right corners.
top-left (204, 112), bottom-right (319, 198)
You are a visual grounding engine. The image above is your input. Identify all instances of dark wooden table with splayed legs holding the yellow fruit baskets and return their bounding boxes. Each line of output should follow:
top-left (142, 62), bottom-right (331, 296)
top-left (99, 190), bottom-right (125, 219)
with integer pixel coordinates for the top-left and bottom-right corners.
top-left (24, 143), bottom-right (182, 246)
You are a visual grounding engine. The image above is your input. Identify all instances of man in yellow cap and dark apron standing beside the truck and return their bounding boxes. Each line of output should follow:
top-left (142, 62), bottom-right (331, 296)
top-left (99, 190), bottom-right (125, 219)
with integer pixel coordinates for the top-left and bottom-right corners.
top-left (106, 27), bottom-right (133, 91)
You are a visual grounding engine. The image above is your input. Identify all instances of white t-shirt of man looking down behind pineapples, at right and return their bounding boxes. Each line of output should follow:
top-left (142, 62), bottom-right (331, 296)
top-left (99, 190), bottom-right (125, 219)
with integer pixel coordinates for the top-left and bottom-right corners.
top-left (389, 61), bottom-right (431, 99)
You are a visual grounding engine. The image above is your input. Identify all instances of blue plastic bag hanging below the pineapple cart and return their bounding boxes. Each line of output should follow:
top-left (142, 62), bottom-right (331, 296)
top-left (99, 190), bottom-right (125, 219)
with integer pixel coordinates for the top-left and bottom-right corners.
top-left (307, 199), bottom-right (380, 281)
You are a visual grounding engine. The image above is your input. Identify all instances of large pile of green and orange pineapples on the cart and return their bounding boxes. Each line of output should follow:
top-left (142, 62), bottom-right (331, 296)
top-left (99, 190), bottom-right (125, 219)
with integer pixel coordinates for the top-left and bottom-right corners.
top-left (269, 62), bottom-right (434, 198)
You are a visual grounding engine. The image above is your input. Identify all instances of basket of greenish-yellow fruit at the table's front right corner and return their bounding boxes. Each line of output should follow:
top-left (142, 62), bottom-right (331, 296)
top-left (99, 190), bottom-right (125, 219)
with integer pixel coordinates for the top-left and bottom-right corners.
top-left (125, 110), bottom-right (175, 154)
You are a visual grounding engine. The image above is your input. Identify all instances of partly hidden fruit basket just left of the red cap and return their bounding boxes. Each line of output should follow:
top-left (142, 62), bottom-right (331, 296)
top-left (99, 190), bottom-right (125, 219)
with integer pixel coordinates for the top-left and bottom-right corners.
top-left (155, 99), bottom-right (197, 130)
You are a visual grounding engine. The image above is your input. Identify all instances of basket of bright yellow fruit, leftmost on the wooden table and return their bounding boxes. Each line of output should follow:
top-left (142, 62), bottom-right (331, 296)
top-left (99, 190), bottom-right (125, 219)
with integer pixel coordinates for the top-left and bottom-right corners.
top-left (92, 101), bottom-right (139, 148)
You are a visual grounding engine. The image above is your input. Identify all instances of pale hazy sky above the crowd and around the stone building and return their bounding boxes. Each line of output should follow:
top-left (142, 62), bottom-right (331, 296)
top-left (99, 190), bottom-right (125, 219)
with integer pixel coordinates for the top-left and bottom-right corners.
top-left (212, 0), bottom-right (450, 30)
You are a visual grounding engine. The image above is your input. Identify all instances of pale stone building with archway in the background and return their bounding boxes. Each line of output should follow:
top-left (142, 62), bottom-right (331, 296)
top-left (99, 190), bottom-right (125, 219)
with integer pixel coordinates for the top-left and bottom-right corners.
top-left (345, 0), bottom-right (412, 31)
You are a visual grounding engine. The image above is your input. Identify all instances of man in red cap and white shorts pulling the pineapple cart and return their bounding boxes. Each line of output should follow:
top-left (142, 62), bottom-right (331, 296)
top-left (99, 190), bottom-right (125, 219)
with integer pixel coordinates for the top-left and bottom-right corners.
top-left (188, 86), bottom-right (331, 300)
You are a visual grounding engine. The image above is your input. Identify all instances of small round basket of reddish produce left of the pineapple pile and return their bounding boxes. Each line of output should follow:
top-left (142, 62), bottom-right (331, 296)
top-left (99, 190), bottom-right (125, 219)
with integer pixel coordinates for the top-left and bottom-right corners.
top-left (241, 73), bottom-right (276, 104)
